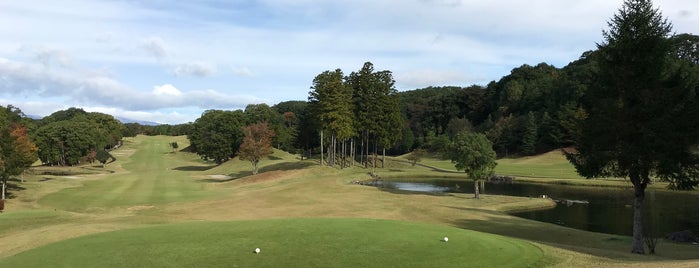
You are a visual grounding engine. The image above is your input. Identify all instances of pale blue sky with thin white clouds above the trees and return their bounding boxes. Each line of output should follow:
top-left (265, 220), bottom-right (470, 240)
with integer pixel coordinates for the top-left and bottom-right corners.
top-left (0, 0), bottom-right (699, 124)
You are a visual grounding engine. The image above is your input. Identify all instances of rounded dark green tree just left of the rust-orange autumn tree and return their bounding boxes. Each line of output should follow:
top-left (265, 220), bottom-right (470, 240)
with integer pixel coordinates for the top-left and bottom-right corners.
top-left (187, 110), bottom-right (248, 164)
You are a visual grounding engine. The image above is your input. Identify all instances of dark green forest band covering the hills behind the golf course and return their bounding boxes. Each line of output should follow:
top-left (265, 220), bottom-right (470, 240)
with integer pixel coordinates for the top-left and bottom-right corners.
top-left (0, 34), bottom-right (699, 173)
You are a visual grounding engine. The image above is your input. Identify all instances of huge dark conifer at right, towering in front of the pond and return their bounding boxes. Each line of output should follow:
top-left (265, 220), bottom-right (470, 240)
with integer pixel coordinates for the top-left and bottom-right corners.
top-left (568, 0), bottom-right (699, 254)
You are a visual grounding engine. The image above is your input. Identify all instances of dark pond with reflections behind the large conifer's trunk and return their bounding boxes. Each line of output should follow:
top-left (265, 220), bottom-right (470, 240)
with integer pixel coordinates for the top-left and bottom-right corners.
top-left (379, 180), bottom-right (699, 236)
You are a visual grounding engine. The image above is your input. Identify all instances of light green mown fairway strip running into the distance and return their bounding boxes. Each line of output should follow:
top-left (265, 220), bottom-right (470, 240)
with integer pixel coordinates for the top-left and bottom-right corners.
top-left (39, 136), bottom-right (226, 211)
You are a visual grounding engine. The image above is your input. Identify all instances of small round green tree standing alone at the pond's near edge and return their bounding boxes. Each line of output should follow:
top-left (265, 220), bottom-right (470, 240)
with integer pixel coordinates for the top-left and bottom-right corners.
top-left (447, 131), bottom-right (497, 199)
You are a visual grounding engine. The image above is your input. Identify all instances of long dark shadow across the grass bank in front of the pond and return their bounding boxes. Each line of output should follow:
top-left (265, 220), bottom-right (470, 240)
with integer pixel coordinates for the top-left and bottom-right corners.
top-left (453, 211), bottom-right (699, 261)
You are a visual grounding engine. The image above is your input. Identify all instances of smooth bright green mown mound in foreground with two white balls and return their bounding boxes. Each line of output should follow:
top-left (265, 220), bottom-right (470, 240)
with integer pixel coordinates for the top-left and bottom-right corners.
top-left (0, 219), bottom-right (545, 267)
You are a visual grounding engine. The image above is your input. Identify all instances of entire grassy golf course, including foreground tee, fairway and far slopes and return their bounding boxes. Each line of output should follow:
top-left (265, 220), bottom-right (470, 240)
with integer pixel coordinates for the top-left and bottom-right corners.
top-left (0, 136), bottom-right (699, 267)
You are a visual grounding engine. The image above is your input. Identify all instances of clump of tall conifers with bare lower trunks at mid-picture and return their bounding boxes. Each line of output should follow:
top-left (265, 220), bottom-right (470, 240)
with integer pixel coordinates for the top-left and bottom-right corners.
top-left (308, 62), bottom-right (403, 167)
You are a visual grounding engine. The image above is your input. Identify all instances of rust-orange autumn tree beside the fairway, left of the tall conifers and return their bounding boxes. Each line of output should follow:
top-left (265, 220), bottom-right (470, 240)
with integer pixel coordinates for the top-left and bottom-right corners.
top-left (238, 122), bottom-right (275, 175)
